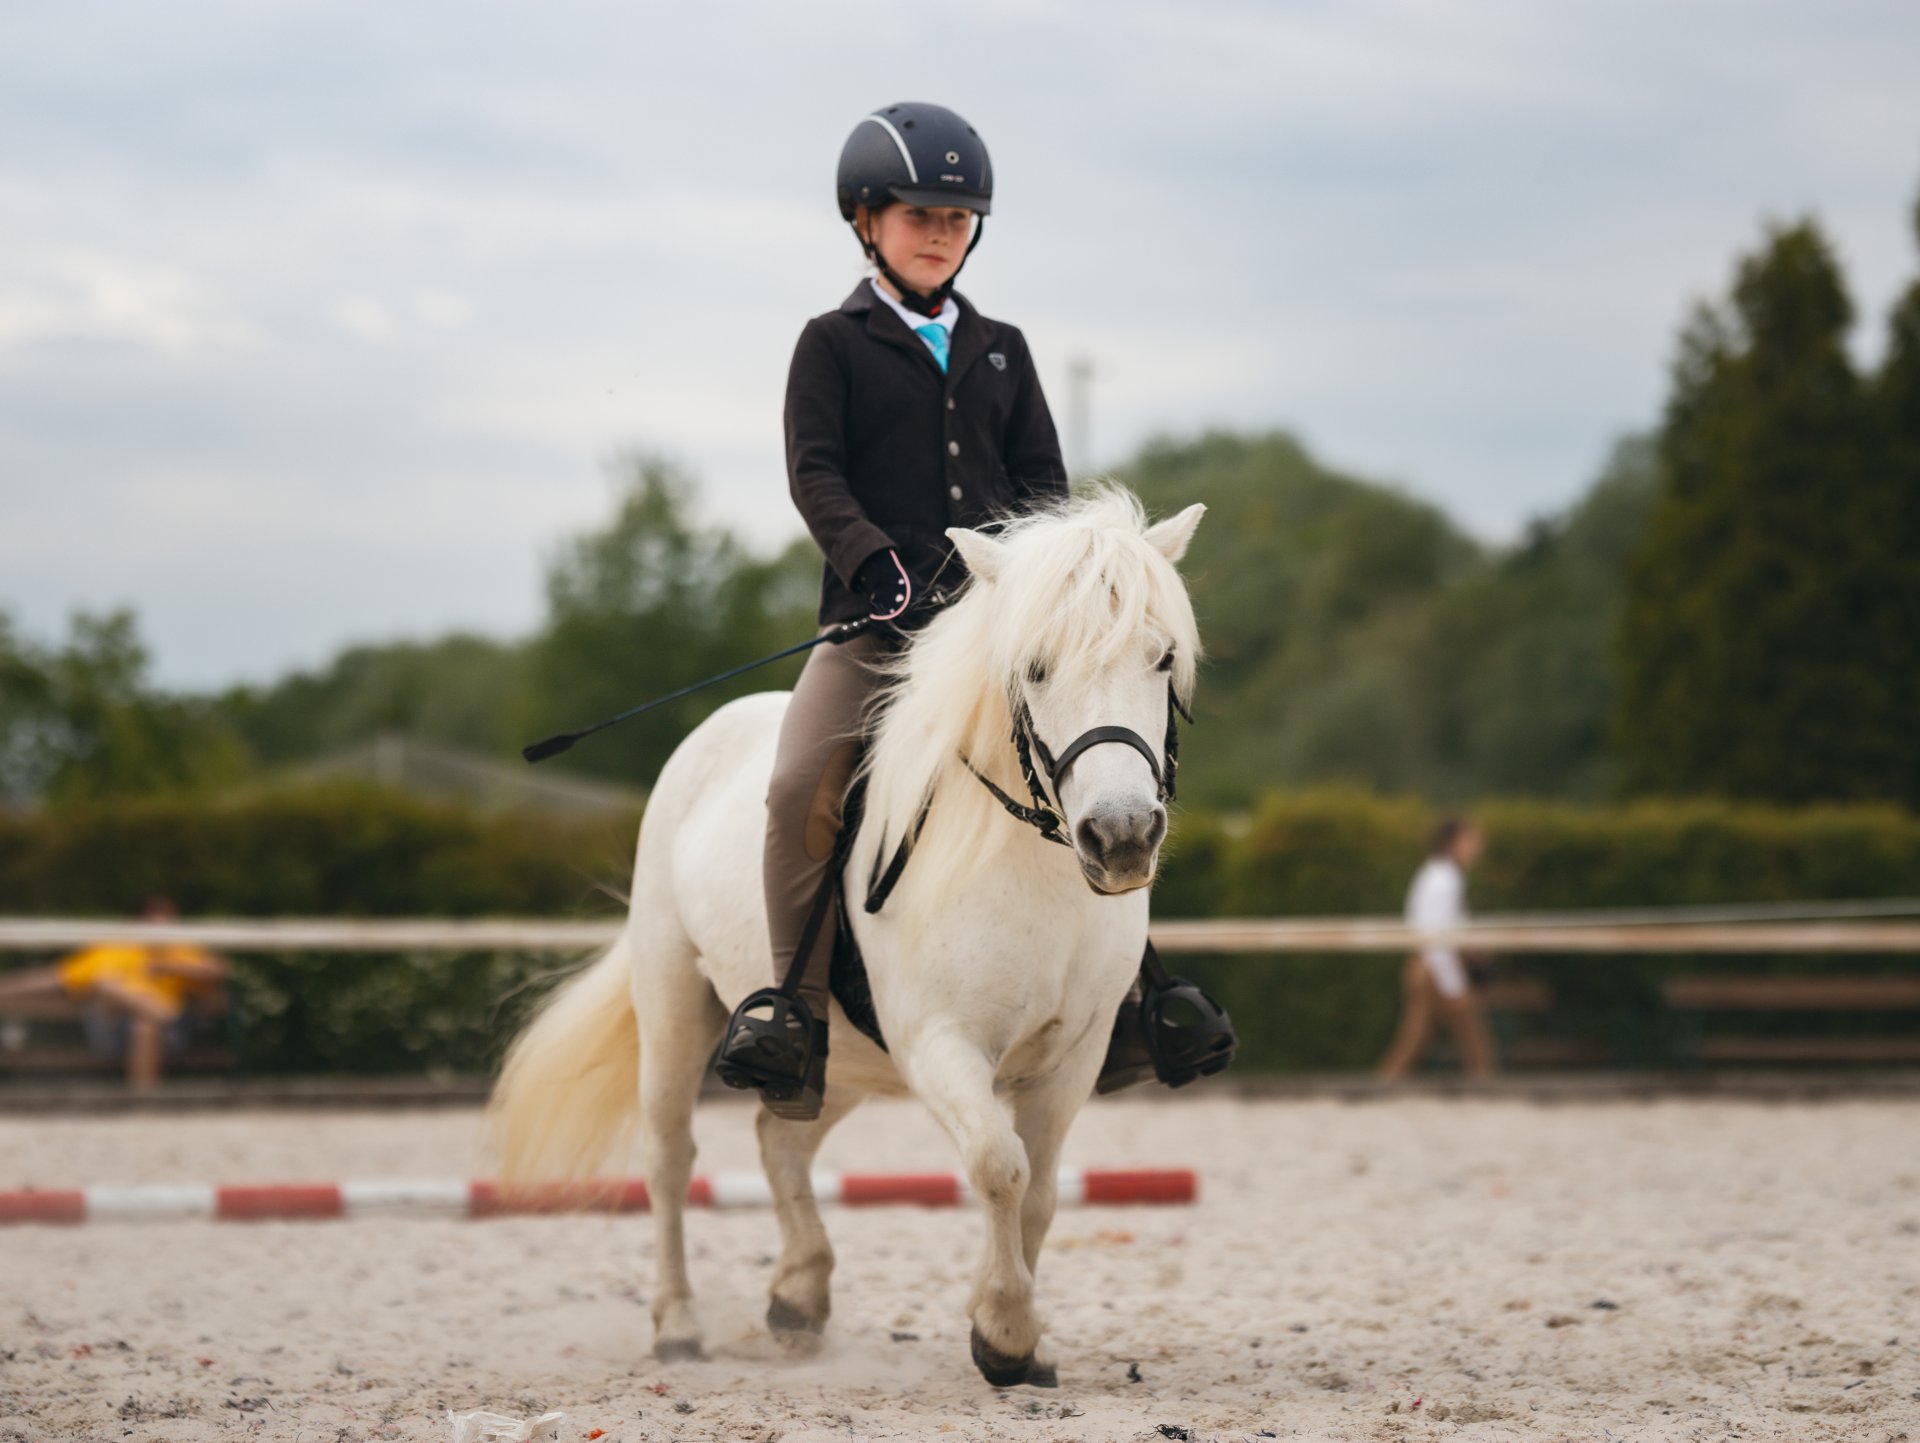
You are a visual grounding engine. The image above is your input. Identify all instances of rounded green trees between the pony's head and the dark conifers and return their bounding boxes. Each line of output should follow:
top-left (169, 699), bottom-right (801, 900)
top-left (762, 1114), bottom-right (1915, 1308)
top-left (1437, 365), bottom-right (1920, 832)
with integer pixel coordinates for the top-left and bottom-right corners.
top-left (1123, 436), bottom-right (1659, 806)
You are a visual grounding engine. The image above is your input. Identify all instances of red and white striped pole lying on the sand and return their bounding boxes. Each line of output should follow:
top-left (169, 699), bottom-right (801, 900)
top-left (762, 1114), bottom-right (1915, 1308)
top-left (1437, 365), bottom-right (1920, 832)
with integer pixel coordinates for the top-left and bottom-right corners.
top-left (0, 1167), bottom-right (1200, 1224)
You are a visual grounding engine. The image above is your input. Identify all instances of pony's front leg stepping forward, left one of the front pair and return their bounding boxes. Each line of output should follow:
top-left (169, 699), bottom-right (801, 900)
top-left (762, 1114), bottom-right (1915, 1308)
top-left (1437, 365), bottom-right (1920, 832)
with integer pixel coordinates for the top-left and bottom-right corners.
top-left (899, 1030), bottom-right (1041, 1387)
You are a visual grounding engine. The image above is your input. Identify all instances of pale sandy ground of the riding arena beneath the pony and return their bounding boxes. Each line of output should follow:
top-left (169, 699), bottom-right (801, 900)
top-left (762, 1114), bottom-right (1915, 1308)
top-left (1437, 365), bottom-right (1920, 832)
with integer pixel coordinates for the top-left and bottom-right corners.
top-left (0, 1090), bottom-right (1920, 1443)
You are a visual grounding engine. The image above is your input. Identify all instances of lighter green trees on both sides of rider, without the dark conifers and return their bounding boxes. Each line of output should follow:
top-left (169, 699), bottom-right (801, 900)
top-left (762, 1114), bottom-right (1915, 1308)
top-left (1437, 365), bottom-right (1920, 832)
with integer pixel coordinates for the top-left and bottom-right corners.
top-left (0, 436), bottom-right (1657, 806)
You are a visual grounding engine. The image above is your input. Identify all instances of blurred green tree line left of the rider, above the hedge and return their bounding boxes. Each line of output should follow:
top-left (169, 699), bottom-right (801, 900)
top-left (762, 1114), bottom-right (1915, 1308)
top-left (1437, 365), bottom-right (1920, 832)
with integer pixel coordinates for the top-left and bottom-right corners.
top-left (0, 457), bottom-right (820, 808)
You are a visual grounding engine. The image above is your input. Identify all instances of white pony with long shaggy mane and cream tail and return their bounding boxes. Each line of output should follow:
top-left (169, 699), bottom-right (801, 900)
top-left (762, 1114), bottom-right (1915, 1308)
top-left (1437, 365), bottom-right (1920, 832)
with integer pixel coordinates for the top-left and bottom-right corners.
top-left (493, 487), bottom-right (1204, 1387)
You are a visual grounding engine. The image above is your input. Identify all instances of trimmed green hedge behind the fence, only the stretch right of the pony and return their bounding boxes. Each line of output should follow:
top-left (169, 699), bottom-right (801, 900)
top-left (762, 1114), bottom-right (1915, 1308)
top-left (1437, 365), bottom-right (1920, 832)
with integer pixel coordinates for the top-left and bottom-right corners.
top-left (1154, 791), bottom-right (1920, 1071)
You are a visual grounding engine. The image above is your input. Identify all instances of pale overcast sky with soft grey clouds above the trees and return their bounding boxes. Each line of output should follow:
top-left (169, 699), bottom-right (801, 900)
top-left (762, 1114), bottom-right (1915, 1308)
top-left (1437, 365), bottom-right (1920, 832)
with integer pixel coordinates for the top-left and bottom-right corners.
top-left (0, 0), bottom-right (1920, 687)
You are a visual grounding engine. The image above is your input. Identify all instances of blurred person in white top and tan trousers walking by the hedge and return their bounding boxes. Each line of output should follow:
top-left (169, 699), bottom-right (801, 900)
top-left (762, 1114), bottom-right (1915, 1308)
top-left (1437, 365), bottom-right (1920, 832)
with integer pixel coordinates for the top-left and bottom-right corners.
top-left (1379, 817), bottom-right (1494, 1080)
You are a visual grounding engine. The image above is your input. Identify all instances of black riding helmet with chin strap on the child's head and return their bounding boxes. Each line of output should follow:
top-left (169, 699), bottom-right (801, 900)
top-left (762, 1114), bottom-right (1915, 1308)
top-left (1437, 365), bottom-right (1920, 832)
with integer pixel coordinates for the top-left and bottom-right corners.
top-left (835, 100), bottom-right (993, 315)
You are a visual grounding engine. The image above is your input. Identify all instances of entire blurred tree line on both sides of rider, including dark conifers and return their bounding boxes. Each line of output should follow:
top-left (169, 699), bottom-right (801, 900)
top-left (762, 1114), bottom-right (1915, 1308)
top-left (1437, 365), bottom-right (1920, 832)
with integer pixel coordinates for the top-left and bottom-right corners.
top-left (0, 192), bottom-right (1920, 810)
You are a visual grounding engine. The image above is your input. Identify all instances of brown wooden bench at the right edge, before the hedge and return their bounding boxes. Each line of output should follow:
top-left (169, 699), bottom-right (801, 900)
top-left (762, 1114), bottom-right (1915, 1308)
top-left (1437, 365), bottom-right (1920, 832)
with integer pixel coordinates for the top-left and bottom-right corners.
top-left (1661, 977), bottom-right (1920, 1063)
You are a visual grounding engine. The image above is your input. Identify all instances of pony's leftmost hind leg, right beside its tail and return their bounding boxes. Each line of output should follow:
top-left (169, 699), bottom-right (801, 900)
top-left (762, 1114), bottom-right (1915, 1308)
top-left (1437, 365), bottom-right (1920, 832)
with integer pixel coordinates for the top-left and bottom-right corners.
top-left (634, 929), bottom-right (726, 1362)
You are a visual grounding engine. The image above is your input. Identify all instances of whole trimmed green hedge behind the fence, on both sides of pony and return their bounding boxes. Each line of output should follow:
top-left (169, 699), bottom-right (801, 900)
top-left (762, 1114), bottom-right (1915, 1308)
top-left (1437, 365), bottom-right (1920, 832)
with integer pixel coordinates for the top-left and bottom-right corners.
top-left (0, 791), bottom-right (1920, 1073)
